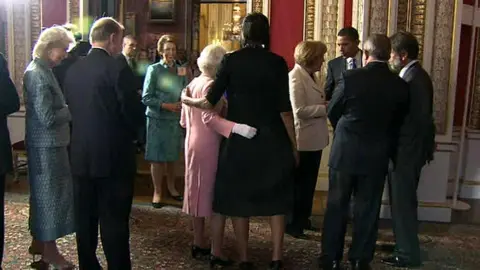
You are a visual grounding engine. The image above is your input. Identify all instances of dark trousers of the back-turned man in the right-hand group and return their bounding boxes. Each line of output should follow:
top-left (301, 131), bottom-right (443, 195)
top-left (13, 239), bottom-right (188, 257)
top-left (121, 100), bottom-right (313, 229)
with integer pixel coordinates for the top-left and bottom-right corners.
top-left (321, 168), bottom-right (385, 262)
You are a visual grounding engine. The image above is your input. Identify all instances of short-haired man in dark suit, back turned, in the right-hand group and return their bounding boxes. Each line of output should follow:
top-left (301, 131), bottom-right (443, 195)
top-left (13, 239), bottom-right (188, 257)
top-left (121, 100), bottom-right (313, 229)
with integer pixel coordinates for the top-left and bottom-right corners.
top-left (320, 35), bottom-right (408, 269)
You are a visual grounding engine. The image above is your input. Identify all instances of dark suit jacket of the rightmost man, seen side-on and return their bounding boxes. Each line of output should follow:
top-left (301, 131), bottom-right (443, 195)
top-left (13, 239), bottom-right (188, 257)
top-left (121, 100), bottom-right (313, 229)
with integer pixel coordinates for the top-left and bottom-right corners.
top-left (396, 63), bottom-right (435, 168)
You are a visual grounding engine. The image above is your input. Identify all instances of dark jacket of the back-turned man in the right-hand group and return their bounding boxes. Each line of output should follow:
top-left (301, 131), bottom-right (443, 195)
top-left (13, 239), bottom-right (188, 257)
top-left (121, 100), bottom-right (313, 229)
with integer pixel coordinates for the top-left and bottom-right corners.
top-left (328, 62), bottom-right (408, 175)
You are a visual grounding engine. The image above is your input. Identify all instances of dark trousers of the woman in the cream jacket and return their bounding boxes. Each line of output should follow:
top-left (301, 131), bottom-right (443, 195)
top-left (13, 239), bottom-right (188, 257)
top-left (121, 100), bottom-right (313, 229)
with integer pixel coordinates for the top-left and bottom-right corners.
top-left (288, 150), bottom-right (322, 232)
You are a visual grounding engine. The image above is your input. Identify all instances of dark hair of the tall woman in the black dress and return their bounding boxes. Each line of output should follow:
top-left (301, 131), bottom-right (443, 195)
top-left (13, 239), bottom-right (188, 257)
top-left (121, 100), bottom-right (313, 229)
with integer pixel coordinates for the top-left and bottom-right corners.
top-left (242, 12), bottom-right (270, 50)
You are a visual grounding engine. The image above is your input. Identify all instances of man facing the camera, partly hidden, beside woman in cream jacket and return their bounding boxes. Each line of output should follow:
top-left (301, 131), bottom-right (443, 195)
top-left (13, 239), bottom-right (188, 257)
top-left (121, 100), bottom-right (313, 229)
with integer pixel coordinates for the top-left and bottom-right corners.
top-left (325, 27), bottom-right (363, 100)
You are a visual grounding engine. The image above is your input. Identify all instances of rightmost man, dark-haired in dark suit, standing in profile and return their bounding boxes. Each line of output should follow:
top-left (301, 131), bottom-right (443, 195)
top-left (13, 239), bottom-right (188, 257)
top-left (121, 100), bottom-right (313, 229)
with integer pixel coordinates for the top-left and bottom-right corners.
top-left (383, 32), bottom-right (435, 267)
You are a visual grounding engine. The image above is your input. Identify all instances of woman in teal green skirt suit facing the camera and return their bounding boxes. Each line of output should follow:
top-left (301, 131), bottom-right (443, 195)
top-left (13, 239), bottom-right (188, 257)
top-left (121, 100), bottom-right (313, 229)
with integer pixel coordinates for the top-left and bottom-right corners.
top-left (142, 35), bottom-right (187, 208)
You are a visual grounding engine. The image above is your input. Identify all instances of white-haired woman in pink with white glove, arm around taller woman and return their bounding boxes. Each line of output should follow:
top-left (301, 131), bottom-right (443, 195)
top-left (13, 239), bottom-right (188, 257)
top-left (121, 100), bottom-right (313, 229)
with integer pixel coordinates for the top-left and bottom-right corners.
top-left (180, 45), bottom-right (256, 266)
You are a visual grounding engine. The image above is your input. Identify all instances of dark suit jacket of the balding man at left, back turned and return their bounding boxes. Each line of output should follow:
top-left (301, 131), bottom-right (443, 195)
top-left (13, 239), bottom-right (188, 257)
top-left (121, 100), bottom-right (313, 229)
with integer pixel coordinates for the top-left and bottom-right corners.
top-left (64, 49), bottom-right (143, 177)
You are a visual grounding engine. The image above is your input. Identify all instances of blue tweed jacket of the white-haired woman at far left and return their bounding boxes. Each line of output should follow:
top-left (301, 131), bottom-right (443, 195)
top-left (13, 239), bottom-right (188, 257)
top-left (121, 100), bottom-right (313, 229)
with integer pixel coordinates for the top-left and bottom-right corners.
top-left (23, 58), bottom-right (70, 147)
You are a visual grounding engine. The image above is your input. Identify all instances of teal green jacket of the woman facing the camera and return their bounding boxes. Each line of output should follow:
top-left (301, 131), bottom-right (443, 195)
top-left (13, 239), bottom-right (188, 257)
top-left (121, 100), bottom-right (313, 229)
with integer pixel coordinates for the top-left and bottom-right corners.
top-left (142, 60), bottom-right (187, 120)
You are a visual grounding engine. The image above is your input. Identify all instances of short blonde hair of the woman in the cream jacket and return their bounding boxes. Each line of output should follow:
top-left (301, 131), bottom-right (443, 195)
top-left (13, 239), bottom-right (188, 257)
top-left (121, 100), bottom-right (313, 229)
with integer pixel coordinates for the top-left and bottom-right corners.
top-left (293, 41), bottom-right (327, 68)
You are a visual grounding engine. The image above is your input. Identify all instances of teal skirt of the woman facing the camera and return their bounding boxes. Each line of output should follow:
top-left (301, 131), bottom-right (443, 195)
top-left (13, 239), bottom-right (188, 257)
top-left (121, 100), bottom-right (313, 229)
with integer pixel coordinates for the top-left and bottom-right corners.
top-left (145, 117), bottom-right (183, 162)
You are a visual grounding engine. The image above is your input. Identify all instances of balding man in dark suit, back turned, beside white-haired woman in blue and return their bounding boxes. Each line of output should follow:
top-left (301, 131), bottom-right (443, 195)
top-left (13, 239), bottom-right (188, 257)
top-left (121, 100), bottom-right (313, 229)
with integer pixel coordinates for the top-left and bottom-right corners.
top-left (65, 18), bottom-right (142, 270)
